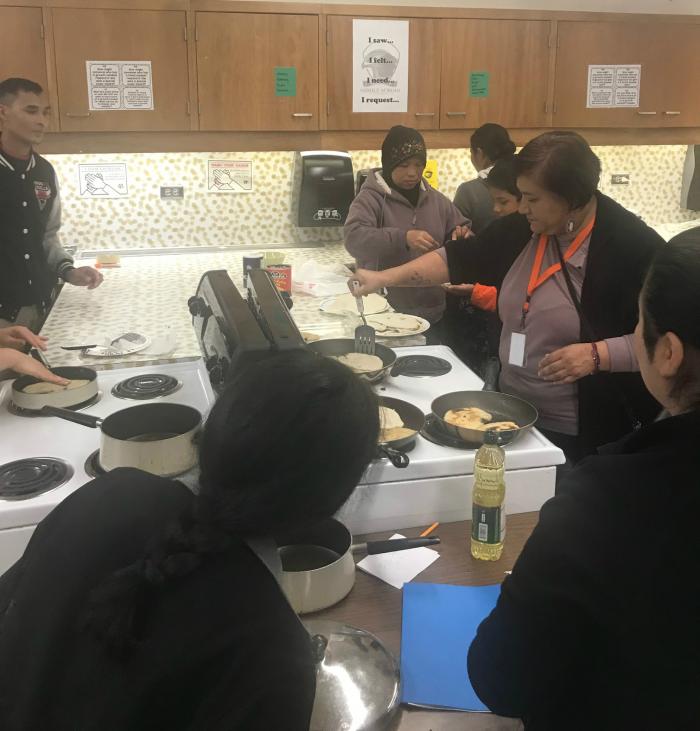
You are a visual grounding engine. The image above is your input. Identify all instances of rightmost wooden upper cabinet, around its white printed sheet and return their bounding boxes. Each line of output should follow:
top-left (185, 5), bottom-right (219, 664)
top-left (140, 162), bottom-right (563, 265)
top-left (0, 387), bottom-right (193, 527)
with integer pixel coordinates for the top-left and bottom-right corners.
top-left (553, 20), bottom-right (700, 127)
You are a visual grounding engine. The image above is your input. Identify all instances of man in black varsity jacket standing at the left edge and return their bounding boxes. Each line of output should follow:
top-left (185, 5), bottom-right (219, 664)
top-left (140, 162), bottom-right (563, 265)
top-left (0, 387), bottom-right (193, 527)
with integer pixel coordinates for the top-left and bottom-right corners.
top-left (0, 79), bottom-right (102, 330)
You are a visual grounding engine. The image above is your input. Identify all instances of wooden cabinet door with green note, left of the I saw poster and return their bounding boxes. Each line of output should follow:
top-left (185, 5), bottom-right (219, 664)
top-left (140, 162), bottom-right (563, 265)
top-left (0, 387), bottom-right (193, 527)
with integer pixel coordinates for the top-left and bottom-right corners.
top-left (197, 12), bottom-right (319, 131)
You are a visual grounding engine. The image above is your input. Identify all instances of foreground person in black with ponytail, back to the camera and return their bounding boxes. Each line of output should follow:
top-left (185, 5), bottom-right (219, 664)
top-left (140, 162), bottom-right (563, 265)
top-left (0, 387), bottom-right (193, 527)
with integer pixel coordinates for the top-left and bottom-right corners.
top-left (0, 350), bottom-right (379, 731)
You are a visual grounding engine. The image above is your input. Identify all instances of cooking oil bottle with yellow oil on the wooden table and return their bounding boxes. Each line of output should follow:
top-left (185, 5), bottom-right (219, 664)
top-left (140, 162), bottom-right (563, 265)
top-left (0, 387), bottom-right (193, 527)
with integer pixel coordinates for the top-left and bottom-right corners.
top-left (471, 431), bottom-right (506, 561)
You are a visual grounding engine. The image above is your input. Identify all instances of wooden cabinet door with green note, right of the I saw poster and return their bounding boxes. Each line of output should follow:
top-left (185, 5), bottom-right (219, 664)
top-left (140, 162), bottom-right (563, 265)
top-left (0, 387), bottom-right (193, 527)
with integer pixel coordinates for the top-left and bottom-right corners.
top-left (440, 19), bottom-right (551, 129)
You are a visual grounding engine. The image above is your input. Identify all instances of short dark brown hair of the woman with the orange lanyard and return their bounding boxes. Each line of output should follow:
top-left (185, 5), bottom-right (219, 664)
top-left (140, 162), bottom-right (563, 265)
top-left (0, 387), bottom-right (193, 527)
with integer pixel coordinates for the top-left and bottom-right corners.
top-left (515, 131), bottom-right (600, 210)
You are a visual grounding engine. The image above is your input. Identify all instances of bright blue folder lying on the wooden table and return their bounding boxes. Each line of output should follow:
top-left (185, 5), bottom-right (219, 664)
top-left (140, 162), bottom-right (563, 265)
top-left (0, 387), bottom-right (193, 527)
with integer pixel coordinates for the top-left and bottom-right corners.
top-left (401, 583), bottom-right (501, 711)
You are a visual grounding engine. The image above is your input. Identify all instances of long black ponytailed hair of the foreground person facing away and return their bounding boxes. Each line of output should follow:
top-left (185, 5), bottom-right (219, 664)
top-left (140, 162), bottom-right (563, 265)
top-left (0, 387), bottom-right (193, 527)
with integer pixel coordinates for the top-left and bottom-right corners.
top-left (80, 350), bottom-right (379, 657)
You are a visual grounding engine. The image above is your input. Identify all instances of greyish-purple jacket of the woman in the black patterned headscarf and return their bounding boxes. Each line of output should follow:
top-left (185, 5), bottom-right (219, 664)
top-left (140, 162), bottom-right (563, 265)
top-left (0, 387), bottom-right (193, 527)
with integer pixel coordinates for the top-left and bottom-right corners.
top-left (344, 168), bottom-right (469, 322)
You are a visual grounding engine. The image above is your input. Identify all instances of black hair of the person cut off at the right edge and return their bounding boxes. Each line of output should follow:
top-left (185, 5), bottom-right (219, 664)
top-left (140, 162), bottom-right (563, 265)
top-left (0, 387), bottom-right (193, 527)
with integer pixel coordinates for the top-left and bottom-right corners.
top-left (639, 226), bottom-right (700, 409)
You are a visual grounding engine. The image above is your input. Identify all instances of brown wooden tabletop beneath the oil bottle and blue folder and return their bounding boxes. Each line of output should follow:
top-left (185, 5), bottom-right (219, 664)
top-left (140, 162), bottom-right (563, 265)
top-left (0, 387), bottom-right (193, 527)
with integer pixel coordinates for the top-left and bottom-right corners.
top-left (306, 513), bottom-right (538, 731)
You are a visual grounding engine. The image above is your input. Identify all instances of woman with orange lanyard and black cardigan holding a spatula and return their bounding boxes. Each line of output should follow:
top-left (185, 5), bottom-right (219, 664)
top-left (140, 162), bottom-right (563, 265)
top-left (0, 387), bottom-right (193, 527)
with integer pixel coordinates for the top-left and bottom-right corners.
top-left (356, 132), bottom-right (663, 462)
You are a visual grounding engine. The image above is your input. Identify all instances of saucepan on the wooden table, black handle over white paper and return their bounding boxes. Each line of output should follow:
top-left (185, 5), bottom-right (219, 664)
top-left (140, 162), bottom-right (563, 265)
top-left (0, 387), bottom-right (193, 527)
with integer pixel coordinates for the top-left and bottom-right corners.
top-left (276, 518), bottom-right (440, 614)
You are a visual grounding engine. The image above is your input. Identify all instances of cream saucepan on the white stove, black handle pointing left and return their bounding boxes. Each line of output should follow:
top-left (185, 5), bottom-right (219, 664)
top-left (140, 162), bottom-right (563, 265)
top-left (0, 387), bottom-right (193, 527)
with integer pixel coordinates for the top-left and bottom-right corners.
top-left (41, 403), bottom-right (202, 477)
